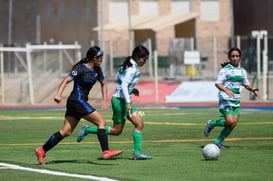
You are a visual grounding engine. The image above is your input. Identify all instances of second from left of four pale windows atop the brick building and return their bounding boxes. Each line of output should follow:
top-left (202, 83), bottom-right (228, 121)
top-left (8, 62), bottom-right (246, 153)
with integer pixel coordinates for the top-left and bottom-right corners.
top-left (139, 0), bottom-right (158, 16)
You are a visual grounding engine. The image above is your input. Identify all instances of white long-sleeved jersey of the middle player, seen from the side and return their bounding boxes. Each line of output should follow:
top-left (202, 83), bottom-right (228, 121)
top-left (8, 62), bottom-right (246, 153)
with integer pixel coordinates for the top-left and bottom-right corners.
top-left (113, 58), bottom-right (140, 103)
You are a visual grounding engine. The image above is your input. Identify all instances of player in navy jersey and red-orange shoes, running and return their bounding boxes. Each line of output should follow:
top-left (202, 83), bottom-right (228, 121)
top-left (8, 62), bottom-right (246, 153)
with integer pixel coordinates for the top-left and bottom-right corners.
top-left (35, 46), bottom-right (122, 165)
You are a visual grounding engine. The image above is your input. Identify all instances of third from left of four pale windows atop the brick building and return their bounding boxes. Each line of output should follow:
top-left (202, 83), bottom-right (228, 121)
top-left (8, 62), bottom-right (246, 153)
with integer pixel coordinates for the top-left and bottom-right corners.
top-left (171, 0), bottom-right (192, 14)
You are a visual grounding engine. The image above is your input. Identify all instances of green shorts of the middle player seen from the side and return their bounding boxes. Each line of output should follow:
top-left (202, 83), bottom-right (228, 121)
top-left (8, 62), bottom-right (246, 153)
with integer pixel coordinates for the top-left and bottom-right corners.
top-left (111, 96), bottom-right (137, 123)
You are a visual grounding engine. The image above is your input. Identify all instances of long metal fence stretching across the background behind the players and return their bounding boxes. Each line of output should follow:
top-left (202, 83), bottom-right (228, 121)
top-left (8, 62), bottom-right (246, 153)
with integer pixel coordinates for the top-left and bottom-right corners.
top-left (0, 36), bottom-right (273, 104)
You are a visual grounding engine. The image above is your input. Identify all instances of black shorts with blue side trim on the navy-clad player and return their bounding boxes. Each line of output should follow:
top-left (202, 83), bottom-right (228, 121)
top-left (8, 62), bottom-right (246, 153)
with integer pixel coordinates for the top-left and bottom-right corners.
top-left (65, 99), bottom-right (96, 120)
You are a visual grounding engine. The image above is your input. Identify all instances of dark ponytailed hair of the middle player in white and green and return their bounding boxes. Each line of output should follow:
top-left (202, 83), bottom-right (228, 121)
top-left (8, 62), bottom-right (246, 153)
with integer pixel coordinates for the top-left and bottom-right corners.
top-left (119, 45), bottom-right (149, 70)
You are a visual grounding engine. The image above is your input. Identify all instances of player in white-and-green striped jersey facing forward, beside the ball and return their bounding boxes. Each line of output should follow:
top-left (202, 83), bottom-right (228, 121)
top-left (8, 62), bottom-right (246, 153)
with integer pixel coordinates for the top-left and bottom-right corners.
top-left (204, 48), bottom-right (261, 148)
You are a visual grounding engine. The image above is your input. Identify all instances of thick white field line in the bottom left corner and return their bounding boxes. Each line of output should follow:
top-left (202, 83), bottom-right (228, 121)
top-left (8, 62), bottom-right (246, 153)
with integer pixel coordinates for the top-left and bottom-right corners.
top-left (0, 162), bottom-right (117, 181)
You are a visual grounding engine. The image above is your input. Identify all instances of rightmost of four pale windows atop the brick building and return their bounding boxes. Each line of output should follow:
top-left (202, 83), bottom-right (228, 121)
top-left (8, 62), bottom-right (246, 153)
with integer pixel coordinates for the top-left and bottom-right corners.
top-left (201, 0), bottom-right (220, 21)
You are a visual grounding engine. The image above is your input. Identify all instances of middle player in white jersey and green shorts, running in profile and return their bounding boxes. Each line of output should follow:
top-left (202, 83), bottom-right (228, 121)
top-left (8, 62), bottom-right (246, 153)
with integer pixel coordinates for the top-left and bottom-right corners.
top-left (77, 45), bottom-right (152, 160)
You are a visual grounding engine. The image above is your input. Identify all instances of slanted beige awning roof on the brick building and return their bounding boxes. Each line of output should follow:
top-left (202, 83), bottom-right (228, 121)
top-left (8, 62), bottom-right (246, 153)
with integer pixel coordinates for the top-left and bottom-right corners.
top-left (93, 12), bottom-right (199, 32)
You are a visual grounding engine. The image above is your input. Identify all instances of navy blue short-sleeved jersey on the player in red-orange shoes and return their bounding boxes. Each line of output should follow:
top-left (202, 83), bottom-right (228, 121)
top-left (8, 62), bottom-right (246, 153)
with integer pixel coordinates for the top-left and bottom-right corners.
top-left (68, 63), bottom-right (104, 101)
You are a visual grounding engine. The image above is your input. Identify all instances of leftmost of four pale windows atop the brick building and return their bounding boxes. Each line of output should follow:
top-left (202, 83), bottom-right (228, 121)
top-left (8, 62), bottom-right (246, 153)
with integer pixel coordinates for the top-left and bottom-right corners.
top-left (109, 0), bottom-right (128, 22)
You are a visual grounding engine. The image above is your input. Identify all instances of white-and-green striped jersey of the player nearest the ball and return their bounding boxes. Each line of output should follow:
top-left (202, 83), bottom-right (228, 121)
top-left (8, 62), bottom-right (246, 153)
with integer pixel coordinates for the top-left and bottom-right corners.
top-left (215, 64), bottom-right (249, 109)
